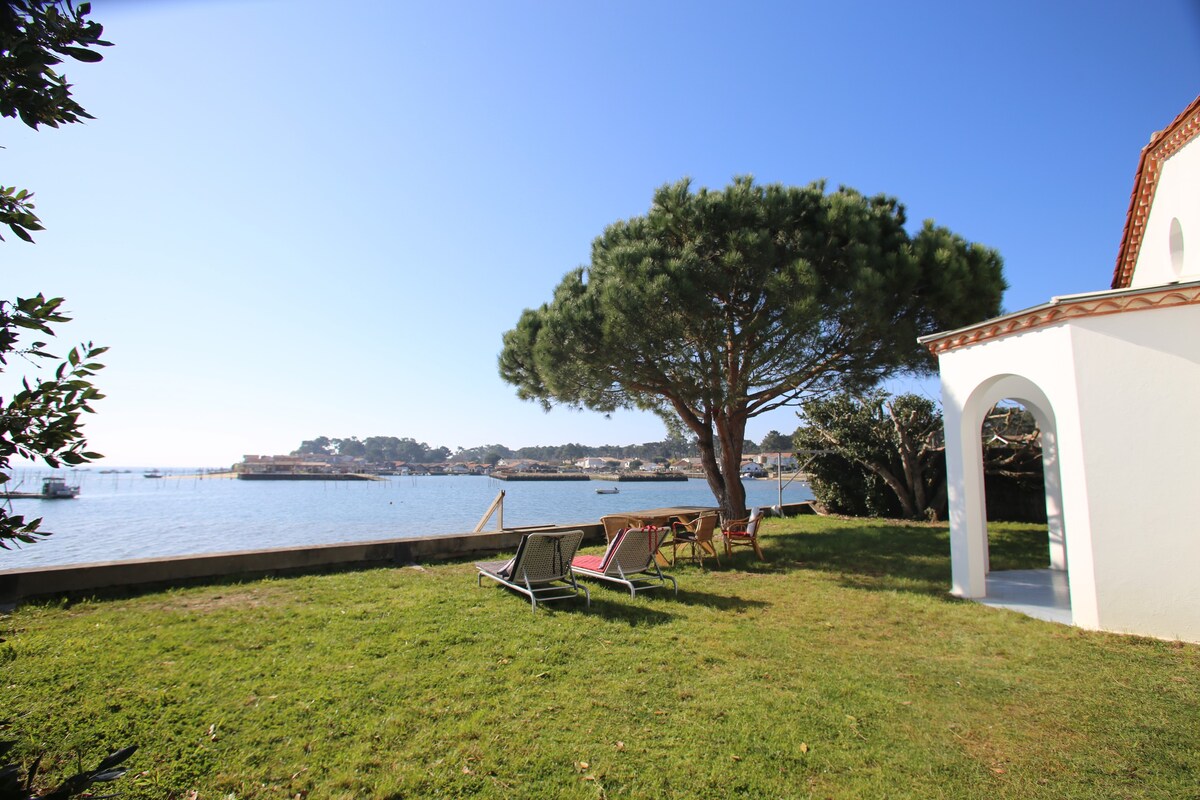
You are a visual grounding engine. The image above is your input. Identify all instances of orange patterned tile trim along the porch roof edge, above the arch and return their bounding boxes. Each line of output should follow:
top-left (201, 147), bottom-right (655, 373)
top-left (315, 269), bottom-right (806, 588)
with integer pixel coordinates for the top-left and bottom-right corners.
top-left (917, 281), bottom-right (1200, 355)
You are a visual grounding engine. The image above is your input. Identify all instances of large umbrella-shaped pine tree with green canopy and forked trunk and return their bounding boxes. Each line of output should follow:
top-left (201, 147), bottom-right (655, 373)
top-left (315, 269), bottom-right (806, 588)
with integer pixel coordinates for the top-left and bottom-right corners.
top-left (499, 178), bottom-right (1004, 515)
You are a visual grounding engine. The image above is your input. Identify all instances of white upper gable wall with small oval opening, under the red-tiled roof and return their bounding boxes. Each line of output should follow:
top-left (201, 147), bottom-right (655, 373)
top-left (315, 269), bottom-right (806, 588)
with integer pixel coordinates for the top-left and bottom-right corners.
top-left (1129, 139), bottom-right (1200, 288)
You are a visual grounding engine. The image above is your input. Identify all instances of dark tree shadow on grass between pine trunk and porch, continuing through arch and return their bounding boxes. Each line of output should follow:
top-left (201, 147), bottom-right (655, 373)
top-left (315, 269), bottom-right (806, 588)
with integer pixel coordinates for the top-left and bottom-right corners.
top-left (733, 521), bottom-right (1048, 597)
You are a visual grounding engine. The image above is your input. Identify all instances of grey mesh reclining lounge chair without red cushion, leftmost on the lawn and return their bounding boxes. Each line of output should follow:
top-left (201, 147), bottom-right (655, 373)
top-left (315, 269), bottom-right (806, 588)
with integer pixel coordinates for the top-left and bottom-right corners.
top-left (475, 530), bottom-right (592, 610)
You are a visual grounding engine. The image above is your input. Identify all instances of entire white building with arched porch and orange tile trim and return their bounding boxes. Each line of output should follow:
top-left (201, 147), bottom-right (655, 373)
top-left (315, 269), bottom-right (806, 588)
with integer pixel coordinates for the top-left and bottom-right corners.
top-left (922, 97), bottom-right (1200, 642)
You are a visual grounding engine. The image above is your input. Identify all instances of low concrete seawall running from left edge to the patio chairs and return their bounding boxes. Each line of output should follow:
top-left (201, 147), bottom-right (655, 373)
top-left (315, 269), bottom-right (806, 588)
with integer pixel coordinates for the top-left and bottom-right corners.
top-left (0, 523), bottom-right (605, 603)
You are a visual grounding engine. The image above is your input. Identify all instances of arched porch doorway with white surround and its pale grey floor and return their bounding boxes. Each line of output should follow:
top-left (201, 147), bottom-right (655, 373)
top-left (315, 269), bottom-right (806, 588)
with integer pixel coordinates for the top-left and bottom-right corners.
top-left (946, 374), bottom-right (1072, 622)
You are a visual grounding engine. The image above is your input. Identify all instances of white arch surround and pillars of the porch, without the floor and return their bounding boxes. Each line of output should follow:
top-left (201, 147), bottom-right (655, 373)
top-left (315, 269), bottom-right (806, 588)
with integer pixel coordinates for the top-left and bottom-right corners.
top-left (943, 373), bottom-right (1067, 597)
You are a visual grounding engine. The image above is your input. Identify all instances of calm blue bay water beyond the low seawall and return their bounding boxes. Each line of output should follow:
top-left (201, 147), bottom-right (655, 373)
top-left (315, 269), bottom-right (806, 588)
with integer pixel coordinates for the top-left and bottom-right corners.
top-left (0, 470), bottom-right (812, 570)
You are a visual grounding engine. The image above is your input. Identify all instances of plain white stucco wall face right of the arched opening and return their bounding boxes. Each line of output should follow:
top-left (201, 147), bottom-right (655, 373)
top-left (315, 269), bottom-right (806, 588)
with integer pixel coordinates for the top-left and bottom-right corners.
top-left (1068, 303), bottom-right (1200, 640)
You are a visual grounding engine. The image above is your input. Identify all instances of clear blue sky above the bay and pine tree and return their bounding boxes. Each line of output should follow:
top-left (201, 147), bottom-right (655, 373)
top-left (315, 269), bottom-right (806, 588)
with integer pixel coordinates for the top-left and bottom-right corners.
top-left (0, 0), bottom-right (1200, 467)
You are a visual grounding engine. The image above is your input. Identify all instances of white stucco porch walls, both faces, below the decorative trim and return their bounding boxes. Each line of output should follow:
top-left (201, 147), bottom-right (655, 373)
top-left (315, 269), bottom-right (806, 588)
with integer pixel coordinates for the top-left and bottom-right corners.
top-left (940, 302), bottom-right (1200, 642)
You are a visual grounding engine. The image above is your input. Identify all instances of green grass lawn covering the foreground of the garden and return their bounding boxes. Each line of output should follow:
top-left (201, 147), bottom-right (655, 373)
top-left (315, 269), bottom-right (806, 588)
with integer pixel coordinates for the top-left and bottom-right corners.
top-left (0, 517), bottom-right (1200, 800)
